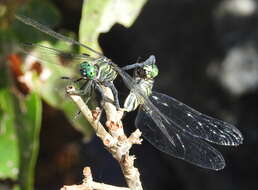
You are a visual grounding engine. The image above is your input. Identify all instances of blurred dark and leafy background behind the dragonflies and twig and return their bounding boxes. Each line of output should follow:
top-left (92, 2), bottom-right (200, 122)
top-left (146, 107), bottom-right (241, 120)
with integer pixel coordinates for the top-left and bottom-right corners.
top-left (0, 0), bottom-right (258, 190)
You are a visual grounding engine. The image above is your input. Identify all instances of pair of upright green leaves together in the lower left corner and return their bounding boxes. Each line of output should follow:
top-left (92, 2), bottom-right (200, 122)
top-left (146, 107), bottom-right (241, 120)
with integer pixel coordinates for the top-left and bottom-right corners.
top-left (0, 89), bottom-right (42, 190)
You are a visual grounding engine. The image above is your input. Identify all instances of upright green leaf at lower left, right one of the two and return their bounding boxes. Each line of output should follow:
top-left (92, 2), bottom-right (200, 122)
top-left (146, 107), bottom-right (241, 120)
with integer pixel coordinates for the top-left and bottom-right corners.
top-left (16, 93), bottom-right (42, 190)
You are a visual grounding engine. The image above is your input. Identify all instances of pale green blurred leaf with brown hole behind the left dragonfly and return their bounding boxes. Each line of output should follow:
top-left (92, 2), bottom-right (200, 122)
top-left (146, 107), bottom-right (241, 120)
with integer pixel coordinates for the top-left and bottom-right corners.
top-left (19, 41), bottom-right (92, 137)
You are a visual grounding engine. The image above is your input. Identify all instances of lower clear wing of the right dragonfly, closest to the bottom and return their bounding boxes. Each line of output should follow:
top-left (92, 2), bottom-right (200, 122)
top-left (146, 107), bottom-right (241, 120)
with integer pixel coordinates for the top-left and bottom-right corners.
top-left (135, 109), bottom-right (225, 170)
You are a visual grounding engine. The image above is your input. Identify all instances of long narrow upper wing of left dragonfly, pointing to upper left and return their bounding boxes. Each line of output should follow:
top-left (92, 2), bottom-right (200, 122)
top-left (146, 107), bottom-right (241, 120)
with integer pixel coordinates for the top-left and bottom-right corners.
top-left (15, 15), bottom-right (104, 57)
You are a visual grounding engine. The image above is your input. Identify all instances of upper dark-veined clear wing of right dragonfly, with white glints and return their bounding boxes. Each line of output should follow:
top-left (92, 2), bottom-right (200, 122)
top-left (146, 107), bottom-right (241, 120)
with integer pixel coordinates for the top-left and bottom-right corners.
top-left (149, 92), bottom-right (243, 146)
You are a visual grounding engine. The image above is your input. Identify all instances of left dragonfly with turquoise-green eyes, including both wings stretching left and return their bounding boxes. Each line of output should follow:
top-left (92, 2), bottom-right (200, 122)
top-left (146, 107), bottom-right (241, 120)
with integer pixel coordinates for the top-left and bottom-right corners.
top-left (16, 15), bottom-right (153, 109)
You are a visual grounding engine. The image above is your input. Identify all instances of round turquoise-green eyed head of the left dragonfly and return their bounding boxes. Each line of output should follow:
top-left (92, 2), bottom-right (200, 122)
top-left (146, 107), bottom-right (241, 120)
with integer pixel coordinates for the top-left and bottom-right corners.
top-left (80, 61), bottom-right (97, 80)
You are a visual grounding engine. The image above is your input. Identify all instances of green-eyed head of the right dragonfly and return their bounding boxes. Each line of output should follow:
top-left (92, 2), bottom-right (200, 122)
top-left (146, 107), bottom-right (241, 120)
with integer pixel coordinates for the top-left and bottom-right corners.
top-left (135, 64), bottom-right (159, 79)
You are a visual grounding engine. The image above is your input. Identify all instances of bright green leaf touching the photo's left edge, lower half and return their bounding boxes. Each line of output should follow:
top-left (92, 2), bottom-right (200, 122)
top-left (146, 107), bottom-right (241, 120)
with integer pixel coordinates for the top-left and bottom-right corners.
top-left (0, 89), bottom-right (19, 180)
